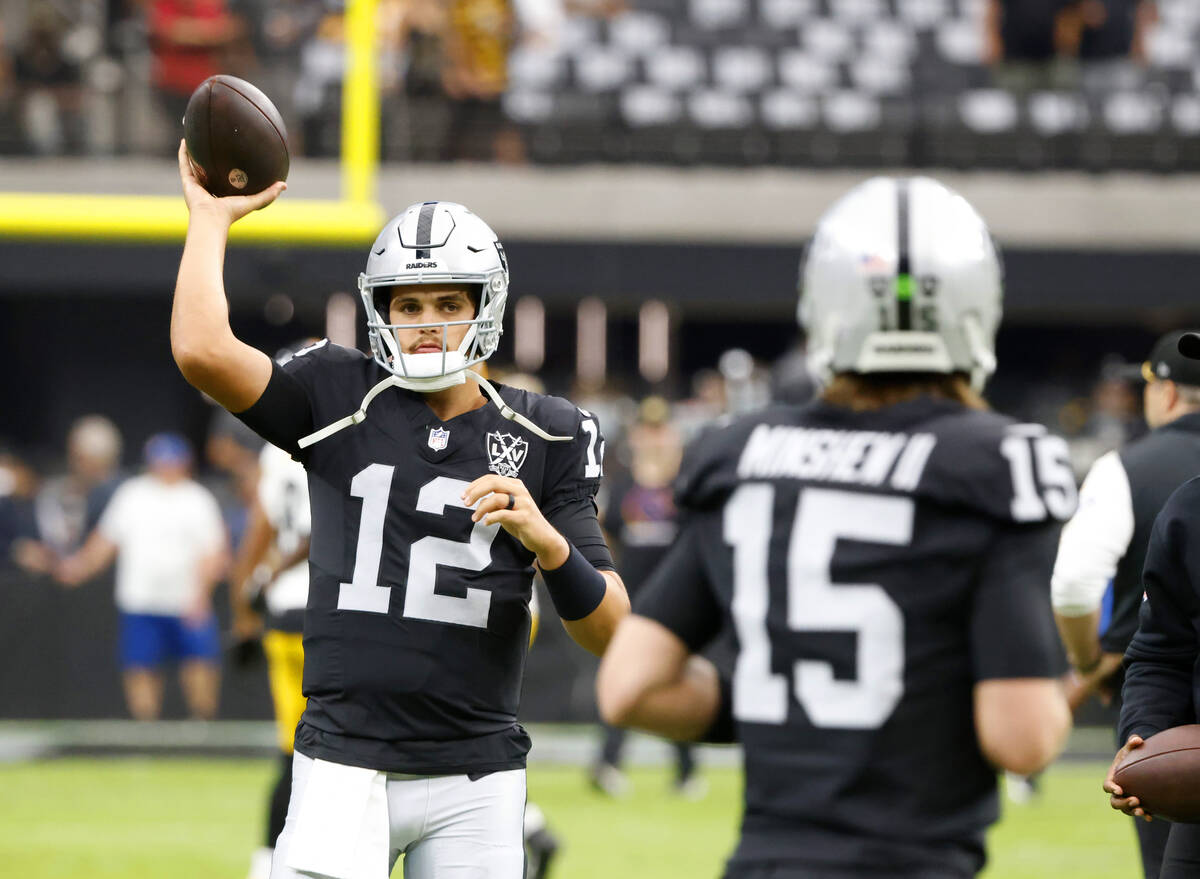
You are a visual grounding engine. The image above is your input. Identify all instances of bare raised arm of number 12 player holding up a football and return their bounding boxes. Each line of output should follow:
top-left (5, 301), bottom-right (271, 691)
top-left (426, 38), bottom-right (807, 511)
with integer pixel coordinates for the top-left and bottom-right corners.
top-left (170, 142), bottom-right (287, 412)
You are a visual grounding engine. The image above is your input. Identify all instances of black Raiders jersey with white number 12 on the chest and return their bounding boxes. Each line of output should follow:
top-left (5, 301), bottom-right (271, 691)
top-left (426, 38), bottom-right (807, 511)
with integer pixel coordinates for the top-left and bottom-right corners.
top-left (240, 342), bottom-right (612, 775)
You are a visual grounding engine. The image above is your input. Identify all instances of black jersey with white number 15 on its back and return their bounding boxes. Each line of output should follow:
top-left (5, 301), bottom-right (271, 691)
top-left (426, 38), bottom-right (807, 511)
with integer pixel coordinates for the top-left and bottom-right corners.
top-left (635, 399), bottom-right (1075, 877)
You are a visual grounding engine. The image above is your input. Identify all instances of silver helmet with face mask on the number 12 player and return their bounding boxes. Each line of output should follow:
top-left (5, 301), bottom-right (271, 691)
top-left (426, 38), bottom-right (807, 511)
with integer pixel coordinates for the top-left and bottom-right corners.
top-left (359, 202), bottom-right (509, 393)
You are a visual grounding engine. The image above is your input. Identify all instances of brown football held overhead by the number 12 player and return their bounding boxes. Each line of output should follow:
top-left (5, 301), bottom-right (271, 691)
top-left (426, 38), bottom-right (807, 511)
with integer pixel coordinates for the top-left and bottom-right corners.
top-left (184, 73), bottom-right (289, 196)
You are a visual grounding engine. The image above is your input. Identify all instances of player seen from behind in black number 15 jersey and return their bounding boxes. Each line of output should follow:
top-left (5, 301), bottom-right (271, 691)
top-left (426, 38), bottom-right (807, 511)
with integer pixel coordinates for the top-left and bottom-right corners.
top-left (598, 178), bottom-right (1075, 879)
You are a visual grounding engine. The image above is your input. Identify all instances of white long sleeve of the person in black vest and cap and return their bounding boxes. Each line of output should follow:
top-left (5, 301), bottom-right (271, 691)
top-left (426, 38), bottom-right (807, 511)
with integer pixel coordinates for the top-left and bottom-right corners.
top-left (1050, 452), bottom-right (1134, 616)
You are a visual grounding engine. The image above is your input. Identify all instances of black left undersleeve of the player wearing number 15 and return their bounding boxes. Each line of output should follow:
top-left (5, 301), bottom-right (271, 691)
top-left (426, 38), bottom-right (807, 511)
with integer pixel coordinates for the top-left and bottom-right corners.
top-left (634, 516), bottom-right (724, 653)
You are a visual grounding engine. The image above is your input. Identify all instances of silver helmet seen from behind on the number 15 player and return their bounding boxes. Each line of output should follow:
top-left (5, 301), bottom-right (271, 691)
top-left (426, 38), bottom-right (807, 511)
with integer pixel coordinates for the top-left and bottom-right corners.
top-left (797, 177), bottom-right (1003, 389)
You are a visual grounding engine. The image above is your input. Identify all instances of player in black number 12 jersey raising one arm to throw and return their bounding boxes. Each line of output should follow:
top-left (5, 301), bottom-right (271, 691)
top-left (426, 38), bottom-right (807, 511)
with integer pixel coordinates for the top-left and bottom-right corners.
top-left (170, 145), bottom-right (629, 879)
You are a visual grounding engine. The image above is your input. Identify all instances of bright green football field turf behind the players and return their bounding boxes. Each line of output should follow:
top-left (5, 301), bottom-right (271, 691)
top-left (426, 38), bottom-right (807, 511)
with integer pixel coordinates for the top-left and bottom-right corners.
top-left (0, 759), bottom-right (1140, 879)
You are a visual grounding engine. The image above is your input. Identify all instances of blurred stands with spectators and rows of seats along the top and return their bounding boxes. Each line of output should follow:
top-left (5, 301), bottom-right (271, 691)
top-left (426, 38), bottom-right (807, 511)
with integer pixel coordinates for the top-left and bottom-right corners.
top-left (0, 0), bottom-right (1180, 168)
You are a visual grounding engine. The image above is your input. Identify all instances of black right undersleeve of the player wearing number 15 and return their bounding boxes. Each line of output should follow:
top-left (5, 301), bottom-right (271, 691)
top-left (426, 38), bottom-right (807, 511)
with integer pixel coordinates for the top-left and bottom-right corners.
top-left (971, 524), bottom-right (1067, 681)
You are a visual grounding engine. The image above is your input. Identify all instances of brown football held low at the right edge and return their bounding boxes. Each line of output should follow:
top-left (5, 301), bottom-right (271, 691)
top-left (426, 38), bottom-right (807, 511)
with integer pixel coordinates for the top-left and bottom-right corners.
top-left (1112, 723), bottom-right (1200, 824)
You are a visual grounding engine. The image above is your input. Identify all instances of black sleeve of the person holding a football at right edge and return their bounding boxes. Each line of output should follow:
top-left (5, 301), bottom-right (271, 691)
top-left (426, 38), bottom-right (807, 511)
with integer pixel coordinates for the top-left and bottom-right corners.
top-left (1120, 480), bottom-right (1200, 741)
